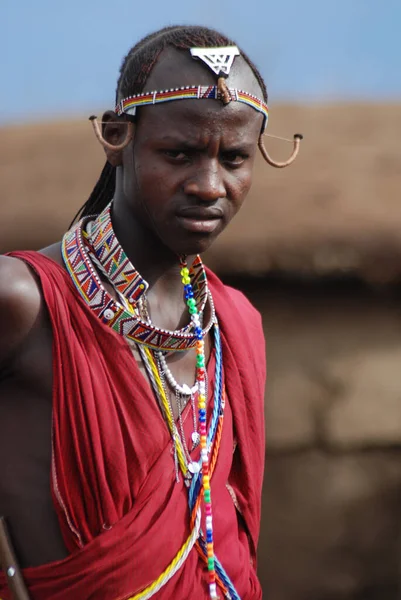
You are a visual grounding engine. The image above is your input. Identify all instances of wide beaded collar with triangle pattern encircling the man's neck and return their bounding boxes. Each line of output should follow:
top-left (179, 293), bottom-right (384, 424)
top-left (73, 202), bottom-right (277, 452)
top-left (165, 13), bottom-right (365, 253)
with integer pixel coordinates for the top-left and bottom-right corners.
top-left (62, 212), bottom-right (215, 352)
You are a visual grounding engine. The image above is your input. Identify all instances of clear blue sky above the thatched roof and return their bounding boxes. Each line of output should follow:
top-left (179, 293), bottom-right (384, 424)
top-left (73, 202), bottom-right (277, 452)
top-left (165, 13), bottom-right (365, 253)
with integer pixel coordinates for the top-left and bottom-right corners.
top-left (0, 0), bottom-right (401, 123)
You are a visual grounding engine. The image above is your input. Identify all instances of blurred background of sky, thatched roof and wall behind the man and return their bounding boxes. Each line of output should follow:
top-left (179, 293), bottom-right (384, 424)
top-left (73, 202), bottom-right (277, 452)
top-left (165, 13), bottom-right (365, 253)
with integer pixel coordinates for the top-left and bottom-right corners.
top-left (0, 0), bottom-right (401, 600)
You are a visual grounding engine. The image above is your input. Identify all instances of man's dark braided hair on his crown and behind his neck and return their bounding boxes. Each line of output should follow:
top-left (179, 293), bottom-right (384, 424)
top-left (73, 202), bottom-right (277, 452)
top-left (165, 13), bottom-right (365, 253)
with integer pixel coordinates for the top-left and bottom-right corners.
top-left (74, 25), bottom-right (267, 221)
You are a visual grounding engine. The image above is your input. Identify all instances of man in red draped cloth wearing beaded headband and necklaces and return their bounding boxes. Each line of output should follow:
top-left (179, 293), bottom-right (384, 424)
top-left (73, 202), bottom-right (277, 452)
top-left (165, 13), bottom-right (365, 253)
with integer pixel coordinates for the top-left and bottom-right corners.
top-left (0, 27), bottom-right (299, 600)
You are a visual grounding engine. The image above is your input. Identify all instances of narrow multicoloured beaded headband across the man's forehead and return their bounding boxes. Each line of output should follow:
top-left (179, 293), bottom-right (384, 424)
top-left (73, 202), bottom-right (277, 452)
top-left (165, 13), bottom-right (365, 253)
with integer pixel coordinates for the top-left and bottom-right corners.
top-left (115, 85), bottom-right (268, 131)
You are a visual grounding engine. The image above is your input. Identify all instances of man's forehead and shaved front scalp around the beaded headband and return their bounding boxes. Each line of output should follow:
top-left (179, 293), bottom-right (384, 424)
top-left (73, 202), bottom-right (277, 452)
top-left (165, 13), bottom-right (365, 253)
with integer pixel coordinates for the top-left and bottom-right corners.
top-left (130, 48), bottom-right (263, 136)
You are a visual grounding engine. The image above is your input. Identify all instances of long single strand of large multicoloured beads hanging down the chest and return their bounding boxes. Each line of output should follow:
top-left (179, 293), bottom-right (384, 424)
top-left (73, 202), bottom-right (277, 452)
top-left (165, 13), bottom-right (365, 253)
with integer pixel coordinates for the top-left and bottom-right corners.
top-left (180, 258), bottom-right (218, 600)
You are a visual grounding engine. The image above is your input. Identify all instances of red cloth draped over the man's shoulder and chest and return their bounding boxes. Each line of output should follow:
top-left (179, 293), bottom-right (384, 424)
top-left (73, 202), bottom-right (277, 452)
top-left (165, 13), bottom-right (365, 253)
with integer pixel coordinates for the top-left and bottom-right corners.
top-left (0, 252), bottom-right (265, 600)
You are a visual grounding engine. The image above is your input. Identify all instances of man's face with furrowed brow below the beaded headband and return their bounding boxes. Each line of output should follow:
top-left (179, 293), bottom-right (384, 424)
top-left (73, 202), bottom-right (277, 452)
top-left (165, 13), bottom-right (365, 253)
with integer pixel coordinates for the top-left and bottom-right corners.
top-left (113, 51), bottom-right (263, 254)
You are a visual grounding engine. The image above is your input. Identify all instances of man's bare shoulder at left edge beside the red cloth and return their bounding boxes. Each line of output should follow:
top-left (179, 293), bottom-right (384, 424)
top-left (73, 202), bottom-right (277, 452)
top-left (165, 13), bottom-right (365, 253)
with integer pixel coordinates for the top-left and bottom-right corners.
top-left (0, 256), bottom-right (42, 364)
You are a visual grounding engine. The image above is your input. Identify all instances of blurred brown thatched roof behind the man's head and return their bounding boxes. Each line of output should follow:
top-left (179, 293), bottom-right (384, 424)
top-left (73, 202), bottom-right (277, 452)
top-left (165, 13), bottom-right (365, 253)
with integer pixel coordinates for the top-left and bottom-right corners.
top-left (0, 104), bottom-right (401, 281)
